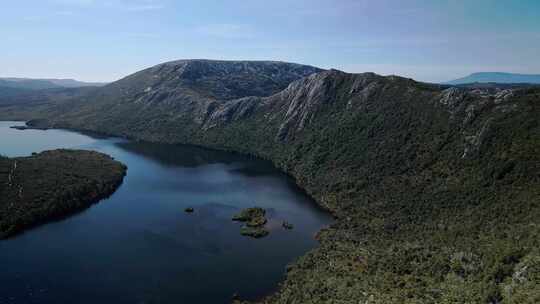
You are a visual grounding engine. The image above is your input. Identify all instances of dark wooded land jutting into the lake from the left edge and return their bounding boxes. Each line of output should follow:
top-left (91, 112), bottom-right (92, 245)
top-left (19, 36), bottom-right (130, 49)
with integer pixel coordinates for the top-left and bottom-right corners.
top-left (0, 150), bottom-right (127, 239)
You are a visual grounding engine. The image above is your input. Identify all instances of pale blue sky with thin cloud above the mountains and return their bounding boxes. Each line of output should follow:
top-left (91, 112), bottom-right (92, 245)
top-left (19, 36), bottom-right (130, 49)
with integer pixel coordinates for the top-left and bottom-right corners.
top-left (0, 0), bottom-right (540, 82)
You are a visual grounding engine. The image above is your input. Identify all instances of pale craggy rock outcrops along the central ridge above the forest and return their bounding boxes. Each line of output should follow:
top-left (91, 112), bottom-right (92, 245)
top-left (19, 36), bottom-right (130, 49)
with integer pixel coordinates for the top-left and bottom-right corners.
top-left (202, 70), bottom-right (392, 142)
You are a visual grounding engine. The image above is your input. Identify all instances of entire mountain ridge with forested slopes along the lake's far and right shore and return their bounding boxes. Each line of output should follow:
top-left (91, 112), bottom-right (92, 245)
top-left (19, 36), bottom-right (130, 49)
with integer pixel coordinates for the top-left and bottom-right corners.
top-left (0, 61), bottom-right (540, 303)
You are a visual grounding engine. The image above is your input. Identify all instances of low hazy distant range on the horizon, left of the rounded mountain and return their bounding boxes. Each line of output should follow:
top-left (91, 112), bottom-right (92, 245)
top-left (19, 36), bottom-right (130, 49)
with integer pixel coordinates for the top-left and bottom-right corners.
top-left (0, 77), bottom-right (105, 90)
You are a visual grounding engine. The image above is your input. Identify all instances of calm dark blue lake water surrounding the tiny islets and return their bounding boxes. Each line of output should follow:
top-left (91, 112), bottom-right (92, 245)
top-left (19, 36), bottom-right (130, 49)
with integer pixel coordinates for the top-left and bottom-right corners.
top-left (0, 122), bottom-right (331, 304)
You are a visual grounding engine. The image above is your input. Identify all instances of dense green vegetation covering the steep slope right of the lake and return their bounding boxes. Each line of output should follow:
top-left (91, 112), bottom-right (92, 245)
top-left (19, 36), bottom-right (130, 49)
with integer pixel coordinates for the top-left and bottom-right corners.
top-left (197, 74), bottom-right (540, 303)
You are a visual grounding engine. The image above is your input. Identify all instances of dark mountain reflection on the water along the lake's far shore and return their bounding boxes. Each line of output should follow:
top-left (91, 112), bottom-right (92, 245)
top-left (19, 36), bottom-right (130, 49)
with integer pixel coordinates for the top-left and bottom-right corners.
top-left (115, 141), bottom-right (278, 176)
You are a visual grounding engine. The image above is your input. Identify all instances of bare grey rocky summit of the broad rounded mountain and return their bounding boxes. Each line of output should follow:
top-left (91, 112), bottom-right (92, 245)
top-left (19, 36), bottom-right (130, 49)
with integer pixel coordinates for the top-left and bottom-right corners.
top-left (102, 60), bottom-right (320, 105)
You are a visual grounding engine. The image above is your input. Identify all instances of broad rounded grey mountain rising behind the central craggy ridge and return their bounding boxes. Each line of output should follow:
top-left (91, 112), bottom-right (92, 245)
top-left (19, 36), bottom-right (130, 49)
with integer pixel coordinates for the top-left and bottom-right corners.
top-left (24, 60), bottom-right (322, 142)
